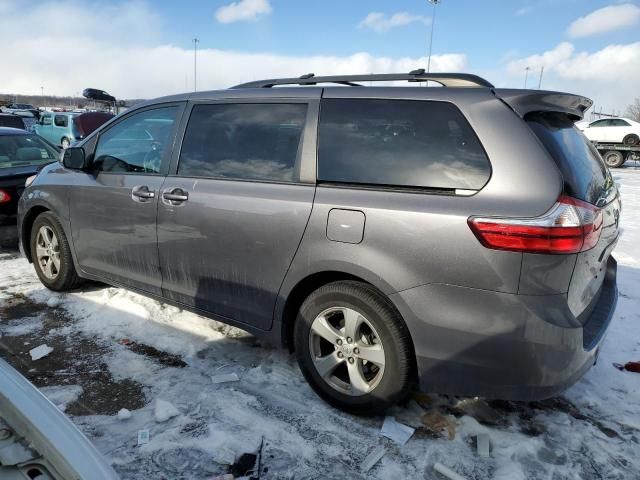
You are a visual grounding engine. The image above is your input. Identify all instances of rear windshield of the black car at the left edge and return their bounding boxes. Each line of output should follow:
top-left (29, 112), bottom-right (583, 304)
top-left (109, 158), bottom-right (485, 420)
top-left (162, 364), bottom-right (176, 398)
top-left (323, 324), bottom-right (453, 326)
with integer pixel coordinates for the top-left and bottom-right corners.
top-left (0, 135), bottom-right (60, 169)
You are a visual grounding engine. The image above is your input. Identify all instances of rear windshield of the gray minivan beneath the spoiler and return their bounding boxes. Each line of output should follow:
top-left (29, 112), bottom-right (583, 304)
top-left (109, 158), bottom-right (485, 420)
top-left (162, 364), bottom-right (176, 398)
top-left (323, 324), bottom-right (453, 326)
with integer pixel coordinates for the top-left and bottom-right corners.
top-left (526, 113), bottom-right (615, 206)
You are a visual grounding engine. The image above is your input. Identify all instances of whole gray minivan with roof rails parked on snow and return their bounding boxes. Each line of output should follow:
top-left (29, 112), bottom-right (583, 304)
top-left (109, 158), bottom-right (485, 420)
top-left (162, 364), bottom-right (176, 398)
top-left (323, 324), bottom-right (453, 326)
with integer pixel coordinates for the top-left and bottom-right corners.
top-left (19, 70), bottom-right (621, 414)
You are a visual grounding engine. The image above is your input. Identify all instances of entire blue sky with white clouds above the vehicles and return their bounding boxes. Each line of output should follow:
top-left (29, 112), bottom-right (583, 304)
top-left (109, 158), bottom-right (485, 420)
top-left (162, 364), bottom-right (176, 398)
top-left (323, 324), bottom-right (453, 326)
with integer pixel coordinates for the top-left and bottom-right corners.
top-left (0, 0), bottom-right (640, 111)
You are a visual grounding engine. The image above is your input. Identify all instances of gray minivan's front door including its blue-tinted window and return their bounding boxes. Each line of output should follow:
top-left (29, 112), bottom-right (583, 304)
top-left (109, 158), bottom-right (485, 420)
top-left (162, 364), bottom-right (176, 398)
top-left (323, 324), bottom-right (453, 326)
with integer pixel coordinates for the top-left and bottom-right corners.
top-left (69, 104), bottom-right (183, 295)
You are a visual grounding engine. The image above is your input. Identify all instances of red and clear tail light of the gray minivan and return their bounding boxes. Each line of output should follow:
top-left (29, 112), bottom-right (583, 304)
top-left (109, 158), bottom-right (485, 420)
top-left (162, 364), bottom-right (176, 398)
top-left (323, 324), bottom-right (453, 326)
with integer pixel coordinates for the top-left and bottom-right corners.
top-left (468, 195), bottom-right (602, 254)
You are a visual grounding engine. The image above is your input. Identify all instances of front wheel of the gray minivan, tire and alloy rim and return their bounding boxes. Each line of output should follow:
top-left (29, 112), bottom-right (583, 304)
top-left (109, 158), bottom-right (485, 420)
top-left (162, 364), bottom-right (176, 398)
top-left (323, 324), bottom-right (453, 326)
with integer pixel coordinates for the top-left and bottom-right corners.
top-left (30, 212), bottom-right (81, 292)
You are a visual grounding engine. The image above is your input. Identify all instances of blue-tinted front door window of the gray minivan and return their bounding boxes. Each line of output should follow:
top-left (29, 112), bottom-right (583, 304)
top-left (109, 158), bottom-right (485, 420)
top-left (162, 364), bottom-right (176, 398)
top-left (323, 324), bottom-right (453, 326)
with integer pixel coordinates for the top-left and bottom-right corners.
top-left (93, 106), bottom-right (178, 174)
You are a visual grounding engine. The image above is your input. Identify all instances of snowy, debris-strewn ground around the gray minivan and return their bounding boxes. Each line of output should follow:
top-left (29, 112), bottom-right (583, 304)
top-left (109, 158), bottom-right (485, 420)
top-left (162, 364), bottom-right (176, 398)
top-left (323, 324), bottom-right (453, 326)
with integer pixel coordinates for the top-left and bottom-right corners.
top-left (0, 168), bottom-right (640, 480)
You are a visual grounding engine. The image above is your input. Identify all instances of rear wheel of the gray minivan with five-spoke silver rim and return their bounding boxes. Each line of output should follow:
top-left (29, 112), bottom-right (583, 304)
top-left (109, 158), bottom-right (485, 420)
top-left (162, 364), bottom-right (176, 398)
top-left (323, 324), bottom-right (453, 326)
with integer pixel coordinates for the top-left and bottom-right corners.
top-left (294, 281), bottom-right (413, 415)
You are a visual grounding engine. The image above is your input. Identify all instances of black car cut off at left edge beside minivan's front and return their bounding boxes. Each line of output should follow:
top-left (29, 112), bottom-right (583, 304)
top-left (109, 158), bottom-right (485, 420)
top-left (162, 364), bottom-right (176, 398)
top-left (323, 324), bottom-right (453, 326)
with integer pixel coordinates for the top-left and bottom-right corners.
top-left (0, 127), bottom-right (60, 244)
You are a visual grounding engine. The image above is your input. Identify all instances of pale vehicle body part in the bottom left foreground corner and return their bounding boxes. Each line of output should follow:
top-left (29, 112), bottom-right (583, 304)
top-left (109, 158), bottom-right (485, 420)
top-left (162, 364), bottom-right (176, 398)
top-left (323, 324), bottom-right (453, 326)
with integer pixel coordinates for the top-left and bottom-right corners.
top-left (0, 359), bottom-right (119, 480)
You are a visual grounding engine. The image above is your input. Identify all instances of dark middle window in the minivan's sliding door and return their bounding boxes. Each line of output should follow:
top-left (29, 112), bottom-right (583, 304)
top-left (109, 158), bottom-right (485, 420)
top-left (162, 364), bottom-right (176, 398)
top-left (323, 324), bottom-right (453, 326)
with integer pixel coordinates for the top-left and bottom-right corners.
top-left (178, 103), bottom-right (307, 182)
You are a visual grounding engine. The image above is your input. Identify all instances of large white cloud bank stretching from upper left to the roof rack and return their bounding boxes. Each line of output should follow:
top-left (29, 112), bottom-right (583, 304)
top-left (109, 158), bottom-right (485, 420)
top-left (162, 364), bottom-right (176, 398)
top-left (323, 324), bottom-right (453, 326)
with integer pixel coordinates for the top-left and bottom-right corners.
top-left (0, 0), bottom-right (466, 98)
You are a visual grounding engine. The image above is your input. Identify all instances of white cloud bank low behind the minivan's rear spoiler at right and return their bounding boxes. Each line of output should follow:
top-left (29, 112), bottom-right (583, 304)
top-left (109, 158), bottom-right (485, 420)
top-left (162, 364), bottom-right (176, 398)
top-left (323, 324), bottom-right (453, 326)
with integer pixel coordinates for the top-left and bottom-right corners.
top-left (501, 42), bottom-right (640, 110)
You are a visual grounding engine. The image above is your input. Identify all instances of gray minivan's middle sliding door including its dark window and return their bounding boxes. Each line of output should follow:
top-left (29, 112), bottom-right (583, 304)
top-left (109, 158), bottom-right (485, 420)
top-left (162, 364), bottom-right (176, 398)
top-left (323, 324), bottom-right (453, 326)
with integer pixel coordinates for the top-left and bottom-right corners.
top-left (158, 100), bottom-right (318, 329)
